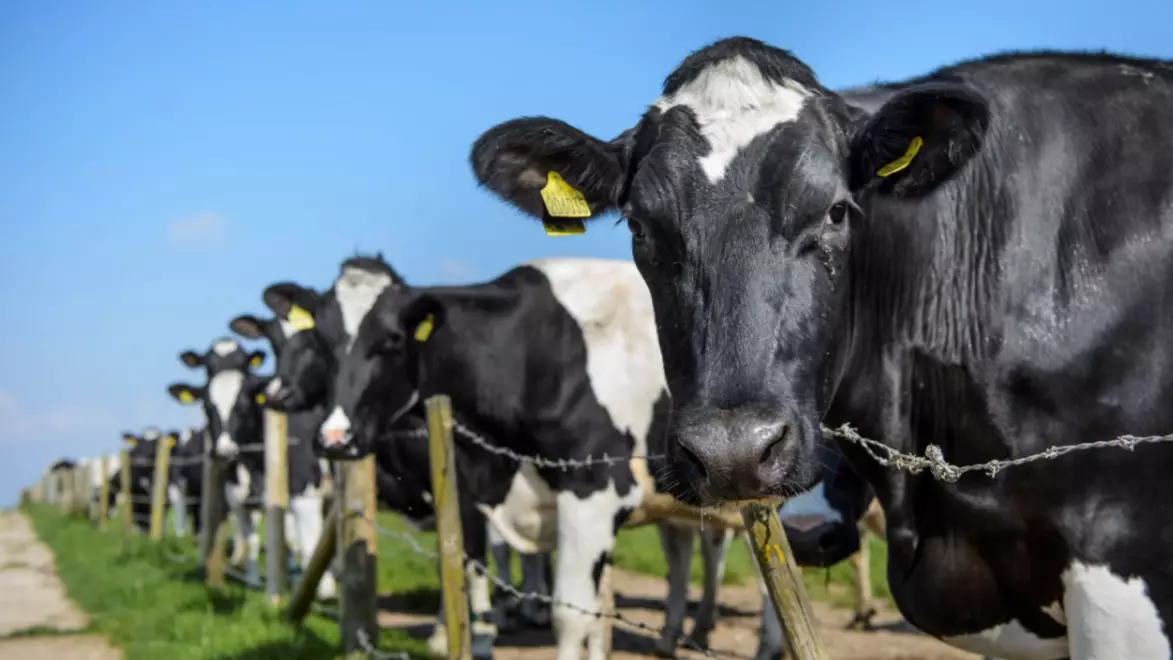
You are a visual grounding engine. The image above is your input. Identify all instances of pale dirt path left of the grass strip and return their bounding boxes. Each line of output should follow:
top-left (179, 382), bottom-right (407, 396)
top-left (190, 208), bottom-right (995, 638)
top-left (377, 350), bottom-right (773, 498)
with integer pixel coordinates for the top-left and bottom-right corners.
top-left (0, 511), bottom-right (122, 660)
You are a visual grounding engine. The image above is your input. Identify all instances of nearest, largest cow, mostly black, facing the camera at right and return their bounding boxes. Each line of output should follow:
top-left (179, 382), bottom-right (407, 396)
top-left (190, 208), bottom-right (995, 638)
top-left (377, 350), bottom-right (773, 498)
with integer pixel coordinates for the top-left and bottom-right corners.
top-left (473, 39), bottom-right (1173, 660)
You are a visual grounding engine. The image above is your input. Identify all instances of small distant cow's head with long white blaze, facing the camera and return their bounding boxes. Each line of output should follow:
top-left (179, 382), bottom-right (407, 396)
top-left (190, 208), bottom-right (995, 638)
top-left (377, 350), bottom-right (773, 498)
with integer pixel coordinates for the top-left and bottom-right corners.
top-left (167, 339), bottom-right (271, 457)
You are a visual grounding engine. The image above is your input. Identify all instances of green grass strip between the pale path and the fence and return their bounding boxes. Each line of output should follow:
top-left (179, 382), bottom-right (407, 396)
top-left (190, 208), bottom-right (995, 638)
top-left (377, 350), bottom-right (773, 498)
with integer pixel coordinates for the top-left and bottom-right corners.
top-left (26, 505), bottom-right (434, 660)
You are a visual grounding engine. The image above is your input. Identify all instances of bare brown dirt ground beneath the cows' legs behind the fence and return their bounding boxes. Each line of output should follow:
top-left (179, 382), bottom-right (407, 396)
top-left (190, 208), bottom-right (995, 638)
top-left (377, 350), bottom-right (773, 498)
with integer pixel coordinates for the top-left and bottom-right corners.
top-left (380, 570), bottom-right (979, 660)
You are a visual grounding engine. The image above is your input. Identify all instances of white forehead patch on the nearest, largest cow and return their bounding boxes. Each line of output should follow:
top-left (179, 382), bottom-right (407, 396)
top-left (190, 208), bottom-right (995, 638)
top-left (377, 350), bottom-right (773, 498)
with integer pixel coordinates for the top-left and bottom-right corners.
top-left (655, 56), bottom-right (812, 183)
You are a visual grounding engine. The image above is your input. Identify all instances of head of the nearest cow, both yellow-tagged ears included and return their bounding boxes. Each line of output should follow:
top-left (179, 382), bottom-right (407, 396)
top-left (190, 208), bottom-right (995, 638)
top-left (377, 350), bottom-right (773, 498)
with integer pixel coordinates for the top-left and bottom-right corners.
top-left (472, 38), bottom-right (989, 503)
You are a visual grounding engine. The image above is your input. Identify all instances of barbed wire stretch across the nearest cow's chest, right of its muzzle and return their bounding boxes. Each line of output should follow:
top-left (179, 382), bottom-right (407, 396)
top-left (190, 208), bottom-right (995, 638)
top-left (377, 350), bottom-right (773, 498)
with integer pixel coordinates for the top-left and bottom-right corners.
top-left (823, 424), bottom-right (1173, 483)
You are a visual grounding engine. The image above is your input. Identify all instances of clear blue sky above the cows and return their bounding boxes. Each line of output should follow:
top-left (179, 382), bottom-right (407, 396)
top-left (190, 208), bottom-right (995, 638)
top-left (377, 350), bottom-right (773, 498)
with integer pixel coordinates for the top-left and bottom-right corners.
top-left (0, 0), bottom-right (1173, 505)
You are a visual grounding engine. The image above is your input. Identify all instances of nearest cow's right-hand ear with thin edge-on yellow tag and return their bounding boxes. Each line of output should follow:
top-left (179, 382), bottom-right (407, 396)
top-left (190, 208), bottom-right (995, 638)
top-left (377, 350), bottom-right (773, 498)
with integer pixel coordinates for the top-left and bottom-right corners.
top-left (848, 83), bottom-right (990, 199)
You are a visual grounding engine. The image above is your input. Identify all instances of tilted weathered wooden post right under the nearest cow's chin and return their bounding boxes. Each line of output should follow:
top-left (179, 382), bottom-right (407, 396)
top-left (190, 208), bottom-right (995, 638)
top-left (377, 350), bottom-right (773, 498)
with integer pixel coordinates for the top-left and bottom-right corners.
top-left (741, 503), bottom-right (827, 660)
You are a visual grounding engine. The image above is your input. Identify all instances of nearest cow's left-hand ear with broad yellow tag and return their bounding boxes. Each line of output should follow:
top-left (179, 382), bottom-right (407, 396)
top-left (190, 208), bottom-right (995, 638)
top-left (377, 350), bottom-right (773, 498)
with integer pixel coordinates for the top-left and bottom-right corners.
top-left (470, 117), bottom-right (631, 234)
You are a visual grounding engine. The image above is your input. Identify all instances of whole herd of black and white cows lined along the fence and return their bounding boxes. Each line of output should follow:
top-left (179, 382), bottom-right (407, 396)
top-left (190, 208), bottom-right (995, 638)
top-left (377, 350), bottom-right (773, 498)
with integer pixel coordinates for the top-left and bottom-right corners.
top-left (41, 38), bottom-right (1173, 660)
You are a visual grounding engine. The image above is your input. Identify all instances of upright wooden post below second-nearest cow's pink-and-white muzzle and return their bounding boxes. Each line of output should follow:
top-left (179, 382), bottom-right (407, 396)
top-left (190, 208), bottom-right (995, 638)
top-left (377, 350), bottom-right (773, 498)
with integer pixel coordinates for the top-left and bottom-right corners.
top-left (335, 455), bottom-right (379, 654)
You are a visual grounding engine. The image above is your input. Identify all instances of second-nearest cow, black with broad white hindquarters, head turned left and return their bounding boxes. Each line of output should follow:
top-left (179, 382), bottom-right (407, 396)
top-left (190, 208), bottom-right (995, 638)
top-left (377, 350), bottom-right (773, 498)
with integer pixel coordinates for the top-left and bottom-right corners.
top-left (263, 254), bottom-right (797, 658)
